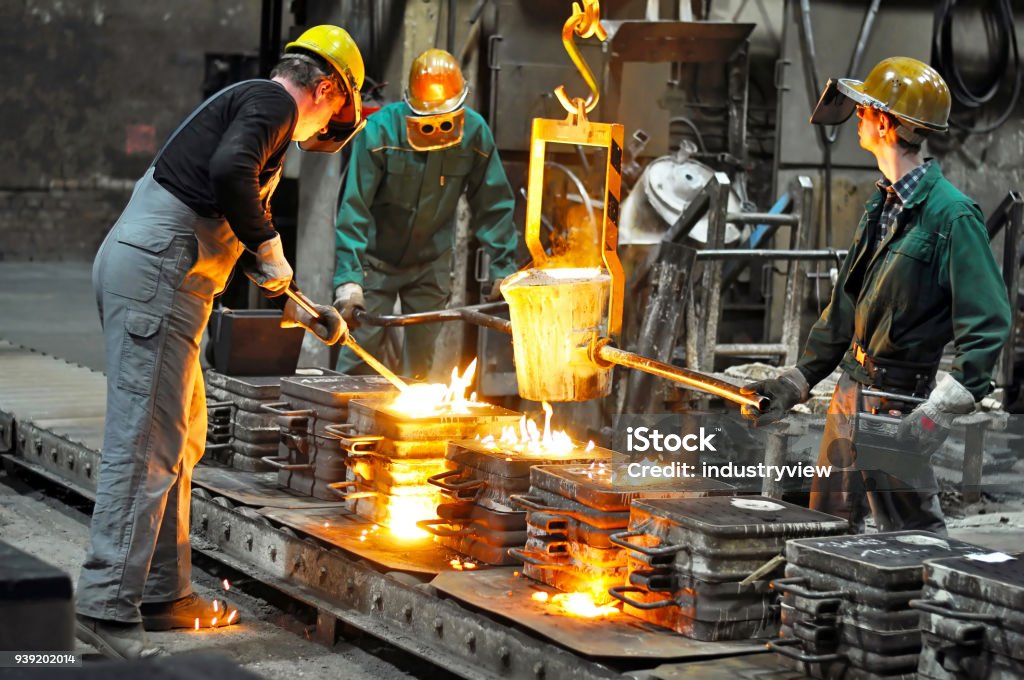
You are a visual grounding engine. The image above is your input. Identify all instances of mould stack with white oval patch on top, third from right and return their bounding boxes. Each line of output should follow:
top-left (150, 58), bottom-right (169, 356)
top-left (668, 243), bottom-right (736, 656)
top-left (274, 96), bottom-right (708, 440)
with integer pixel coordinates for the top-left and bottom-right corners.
top-left (611, 496), bottom-right (847, 641)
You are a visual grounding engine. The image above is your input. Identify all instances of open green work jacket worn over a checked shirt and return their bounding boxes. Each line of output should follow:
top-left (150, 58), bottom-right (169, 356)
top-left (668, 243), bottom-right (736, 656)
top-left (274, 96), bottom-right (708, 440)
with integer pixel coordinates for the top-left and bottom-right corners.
top-left (797, 162), bottom-right (1010, 399)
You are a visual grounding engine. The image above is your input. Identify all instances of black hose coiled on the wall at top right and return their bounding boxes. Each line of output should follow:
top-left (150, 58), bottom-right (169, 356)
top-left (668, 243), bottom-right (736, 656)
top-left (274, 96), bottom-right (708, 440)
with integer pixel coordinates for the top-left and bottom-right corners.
top-left (932, 0), bottom-right (1021, 134)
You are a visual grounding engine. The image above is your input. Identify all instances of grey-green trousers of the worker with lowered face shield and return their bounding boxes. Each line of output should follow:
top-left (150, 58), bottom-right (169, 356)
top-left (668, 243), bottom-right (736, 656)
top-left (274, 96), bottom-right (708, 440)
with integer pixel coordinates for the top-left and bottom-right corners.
top-left (338, 251), bottom-right (452, 380)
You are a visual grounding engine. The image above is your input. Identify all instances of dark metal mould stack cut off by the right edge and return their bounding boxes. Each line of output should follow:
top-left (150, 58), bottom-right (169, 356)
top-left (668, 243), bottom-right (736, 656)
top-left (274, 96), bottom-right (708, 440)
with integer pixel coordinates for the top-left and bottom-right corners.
top-left (910, 553), bottom-right (1024, 680)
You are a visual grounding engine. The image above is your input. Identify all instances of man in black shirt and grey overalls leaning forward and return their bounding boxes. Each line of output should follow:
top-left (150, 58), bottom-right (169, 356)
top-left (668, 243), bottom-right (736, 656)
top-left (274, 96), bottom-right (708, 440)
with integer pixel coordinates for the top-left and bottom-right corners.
top-left (76, 26), bottom-right (364, 658)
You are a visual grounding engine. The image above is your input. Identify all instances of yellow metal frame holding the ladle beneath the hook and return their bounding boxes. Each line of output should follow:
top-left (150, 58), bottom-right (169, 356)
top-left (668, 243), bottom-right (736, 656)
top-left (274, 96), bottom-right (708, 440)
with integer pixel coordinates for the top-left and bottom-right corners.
top-left (525, 114), bottom-right (626, 336)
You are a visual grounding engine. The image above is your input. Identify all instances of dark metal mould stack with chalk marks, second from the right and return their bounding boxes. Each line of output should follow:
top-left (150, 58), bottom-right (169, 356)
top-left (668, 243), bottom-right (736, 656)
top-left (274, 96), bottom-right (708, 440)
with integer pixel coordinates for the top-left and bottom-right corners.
top-left (770, 532), bottom-right (984, 680)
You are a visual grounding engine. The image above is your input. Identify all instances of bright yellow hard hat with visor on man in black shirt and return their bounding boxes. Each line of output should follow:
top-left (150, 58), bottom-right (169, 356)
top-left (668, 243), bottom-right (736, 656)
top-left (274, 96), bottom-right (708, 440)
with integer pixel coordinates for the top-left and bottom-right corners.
top-left (285, 25), bottom-right (366, 153)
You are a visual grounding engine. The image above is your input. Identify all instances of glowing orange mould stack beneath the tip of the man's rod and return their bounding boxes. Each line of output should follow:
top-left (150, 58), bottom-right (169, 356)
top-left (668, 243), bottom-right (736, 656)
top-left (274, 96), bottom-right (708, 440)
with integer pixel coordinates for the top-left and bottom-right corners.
top-left (332, 399), bottom-right (521, 537)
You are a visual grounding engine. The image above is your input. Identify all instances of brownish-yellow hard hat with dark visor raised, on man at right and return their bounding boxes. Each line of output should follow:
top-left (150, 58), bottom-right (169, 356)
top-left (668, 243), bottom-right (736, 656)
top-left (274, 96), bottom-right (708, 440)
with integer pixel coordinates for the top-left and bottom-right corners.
top-left (811, 56), bottom-right (951, 132)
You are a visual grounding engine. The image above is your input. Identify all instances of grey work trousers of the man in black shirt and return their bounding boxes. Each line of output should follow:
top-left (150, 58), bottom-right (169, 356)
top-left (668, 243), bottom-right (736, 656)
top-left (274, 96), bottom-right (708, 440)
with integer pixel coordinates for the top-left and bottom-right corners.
top-left (77, 169), bottom-right (243, 623)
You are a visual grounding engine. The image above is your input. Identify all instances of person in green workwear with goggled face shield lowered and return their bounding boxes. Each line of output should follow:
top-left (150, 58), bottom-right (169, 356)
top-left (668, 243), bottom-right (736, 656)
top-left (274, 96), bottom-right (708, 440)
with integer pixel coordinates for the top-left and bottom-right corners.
top-left (334, 49), bottom-right (518, 378)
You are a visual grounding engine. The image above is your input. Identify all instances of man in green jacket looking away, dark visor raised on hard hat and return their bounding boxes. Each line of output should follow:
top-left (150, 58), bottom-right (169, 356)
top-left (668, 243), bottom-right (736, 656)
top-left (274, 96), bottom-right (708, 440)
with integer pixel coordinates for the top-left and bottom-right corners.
top-left (744, 57), bottom-right (1010, 534)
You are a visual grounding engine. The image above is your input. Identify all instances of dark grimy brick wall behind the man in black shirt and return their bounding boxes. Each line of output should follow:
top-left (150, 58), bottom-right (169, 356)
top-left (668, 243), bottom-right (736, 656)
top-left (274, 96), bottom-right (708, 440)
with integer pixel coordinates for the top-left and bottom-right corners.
top-left (0, 0), bottom-right (260, 260)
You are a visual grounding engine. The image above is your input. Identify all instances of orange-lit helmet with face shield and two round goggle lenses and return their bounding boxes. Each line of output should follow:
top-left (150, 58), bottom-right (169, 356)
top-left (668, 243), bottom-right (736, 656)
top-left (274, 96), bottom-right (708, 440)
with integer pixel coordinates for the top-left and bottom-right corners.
top-left (404, 49), bottom-right (469, 152)
